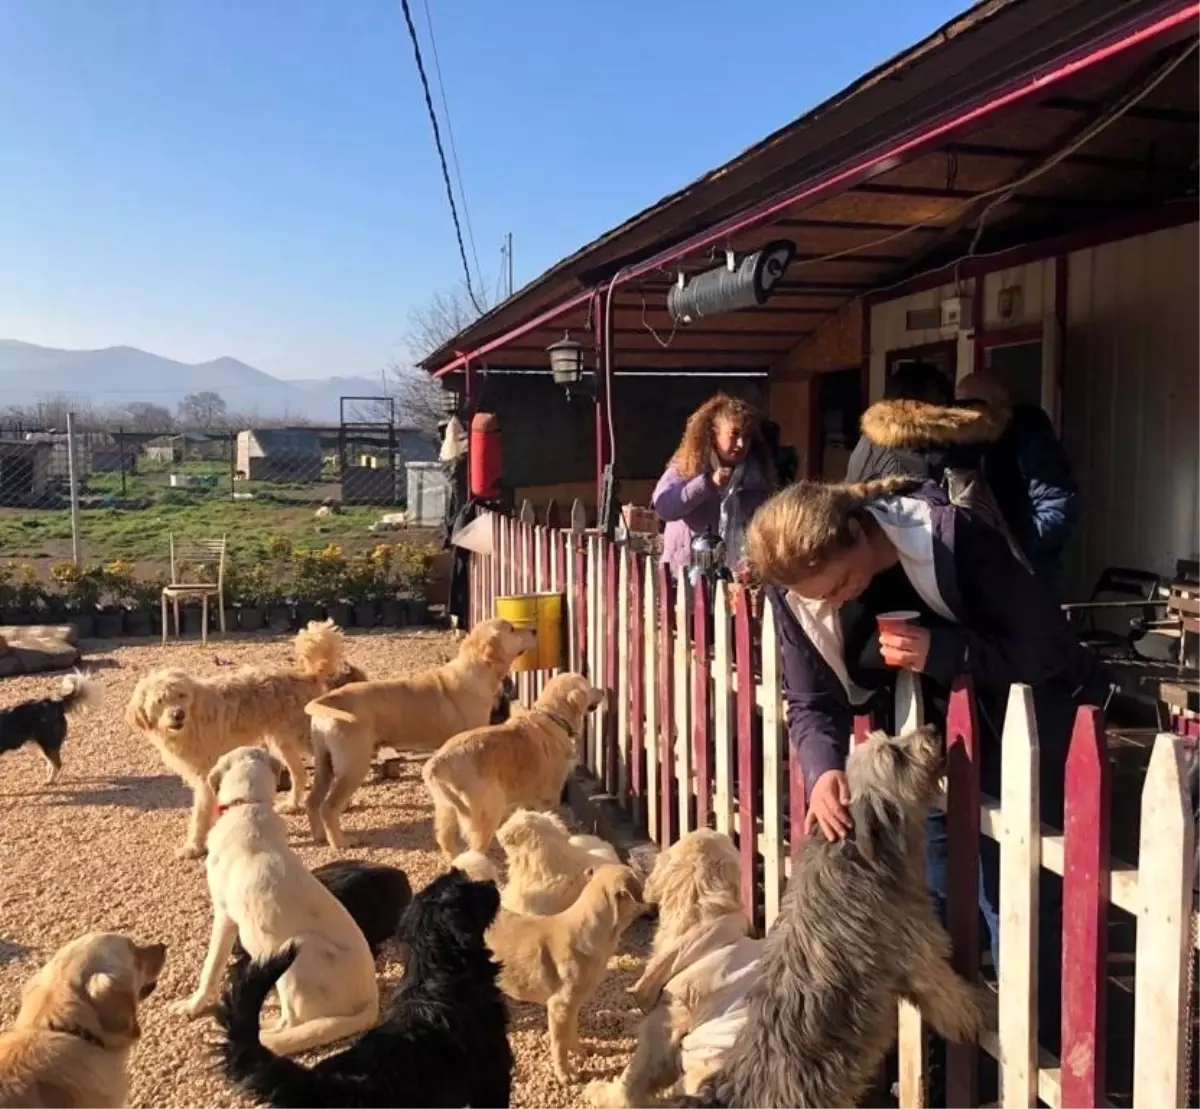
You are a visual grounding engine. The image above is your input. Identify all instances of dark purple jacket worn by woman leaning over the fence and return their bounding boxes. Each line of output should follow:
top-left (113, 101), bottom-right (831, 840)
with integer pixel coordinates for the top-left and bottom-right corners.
top-left (768, 482), bottom-right (1106, 793)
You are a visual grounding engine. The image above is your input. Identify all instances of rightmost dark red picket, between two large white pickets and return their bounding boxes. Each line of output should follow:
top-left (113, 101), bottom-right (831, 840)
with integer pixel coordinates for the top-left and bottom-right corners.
top-left (1060, 706), bottom-right (1110, 1109)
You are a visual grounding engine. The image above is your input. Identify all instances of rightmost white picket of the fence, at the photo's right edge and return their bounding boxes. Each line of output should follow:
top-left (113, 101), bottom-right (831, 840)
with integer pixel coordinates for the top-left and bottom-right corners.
top-left (1133, 735), bottom-right (1195, 1109)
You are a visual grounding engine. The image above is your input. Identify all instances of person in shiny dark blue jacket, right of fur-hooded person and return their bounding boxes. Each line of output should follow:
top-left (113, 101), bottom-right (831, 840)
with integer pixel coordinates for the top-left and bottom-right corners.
top-left (958, 371), bottom-right (1079, 581)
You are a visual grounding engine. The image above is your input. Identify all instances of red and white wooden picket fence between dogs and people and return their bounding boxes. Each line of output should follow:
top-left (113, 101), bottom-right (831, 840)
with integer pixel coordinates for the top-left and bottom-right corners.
top-left (470, 509), bottom-right (1198, 1109)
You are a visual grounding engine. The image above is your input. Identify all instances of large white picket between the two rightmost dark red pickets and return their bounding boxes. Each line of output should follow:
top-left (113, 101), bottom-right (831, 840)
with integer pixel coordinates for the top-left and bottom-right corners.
top-left (998, 685), bottom-right (1042, 1109)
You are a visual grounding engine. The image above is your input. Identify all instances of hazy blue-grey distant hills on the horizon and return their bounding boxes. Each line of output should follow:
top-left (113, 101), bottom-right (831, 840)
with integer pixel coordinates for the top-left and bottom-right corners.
top-left (0, 338), bottom-right (393, 424)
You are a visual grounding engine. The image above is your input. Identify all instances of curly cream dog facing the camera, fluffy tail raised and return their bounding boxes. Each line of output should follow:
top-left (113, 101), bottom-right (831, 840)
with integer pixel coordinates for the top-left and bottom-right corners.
top-left (125, 621), bottom-right (362, 858)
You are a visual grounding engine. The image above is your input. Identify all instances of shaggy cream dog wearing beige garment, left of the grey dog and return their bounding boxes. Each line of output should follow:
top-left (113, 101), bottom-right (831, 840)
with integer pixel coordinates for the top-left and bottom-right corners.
top-left (584, 828), bottom-right (763, 1109)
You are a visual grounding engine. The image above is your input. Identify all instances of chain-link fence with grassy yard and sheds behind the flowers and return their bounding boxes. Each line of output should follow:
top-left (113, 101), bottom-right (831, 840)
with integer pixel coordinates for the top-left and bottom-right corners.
top-left (0, 424), bottom-right (443, 624)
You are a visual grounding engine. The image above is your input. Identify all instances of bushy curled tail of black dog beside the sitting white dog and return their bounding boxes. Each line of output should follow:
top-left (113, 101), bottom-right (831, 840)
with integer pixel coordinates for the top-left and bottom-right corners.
top-left (216, 943), bottom-right (316, 1107)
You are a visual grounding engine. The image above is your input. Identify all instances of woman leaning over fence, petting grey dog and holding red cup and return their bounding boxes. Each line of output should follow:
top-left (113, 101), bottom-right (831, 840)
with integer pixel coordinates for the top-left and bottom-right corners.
top-left (748, 479), bottom-right (1108, 1047)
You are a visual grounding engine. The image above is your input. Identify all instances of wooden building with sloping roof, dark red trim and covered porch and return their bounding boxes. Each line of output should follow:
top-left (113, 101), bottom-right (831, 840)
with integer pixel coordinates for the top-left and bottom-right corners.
top-left (425, 0), bottom-right (1200, 595)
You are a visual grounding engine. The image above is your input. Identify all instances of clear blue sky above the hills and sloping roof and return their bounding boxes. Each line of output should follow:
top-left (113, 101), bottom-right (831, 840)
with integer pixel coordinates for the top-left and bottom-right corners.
top-left (0, 0), bottom-right (965, 378)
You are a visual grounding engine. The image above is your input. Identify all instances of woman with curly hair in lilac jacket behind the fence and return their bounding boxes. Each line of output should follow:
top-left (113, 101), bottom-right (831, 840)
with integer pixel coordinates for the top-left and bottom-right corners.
top-left (652, 392), bottom-right (775, 570)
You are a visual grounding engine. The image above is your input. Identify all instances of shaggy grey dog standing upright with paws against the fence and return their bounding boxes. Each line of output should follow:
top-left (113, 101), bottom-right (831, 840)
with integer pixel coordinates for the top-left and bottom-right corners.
top-left (670, 729), bottom-right (983, 1109)
